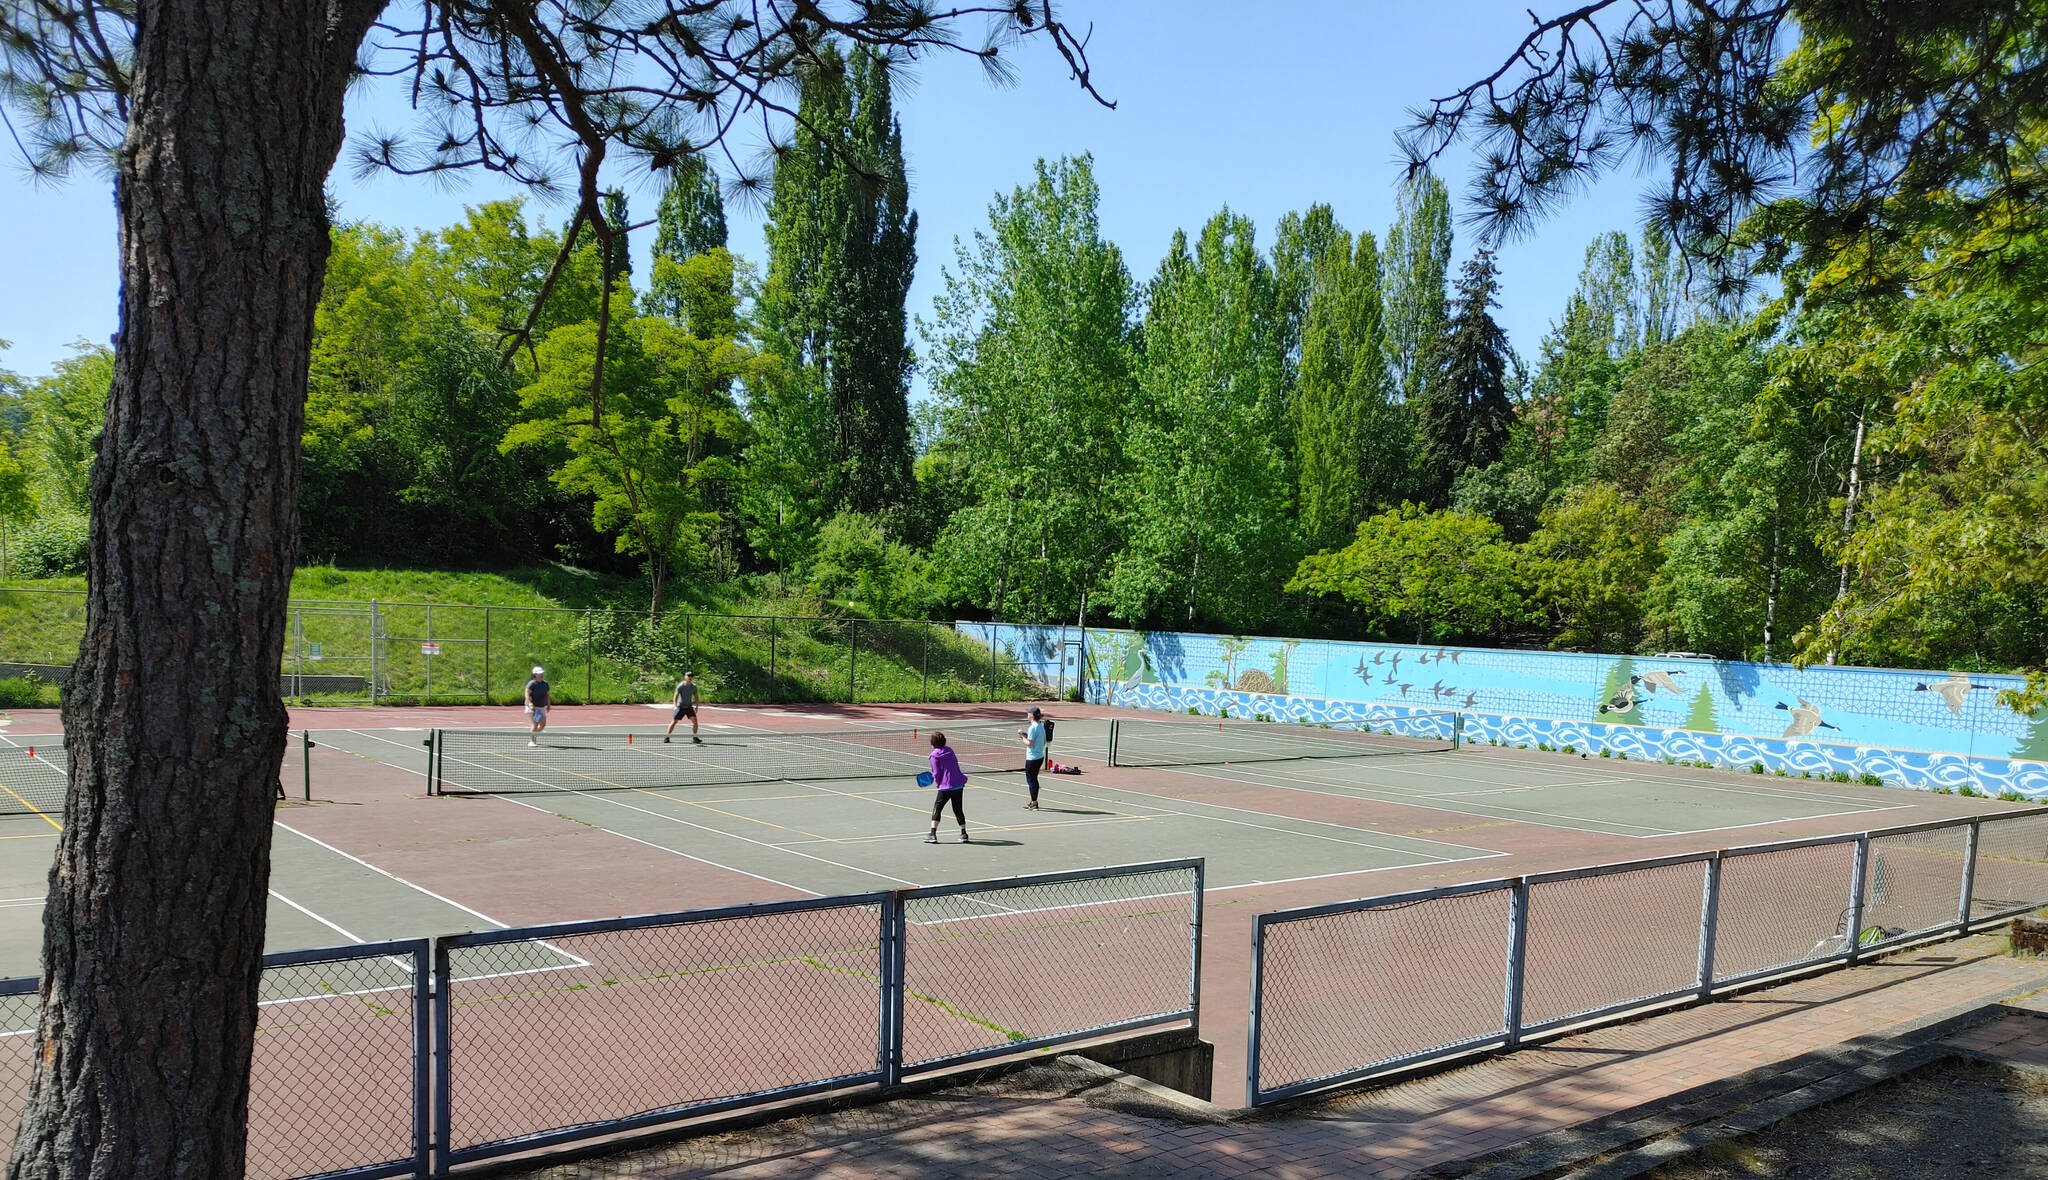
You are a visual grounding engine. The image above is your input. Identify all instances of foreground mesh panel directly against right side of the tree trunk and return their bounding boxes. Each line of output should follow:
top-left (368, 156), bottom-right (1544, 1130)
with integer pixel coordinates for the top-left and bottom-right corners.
top-left (248, 940), bottom-right (428, 1180)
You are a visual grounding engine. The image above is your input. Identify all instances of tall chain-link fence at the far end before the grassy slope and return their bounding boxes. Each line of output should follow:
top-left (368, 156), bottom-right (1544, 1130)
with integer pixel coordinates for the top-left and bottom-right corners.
top-left (0, 588), bottom-right (1056, 705)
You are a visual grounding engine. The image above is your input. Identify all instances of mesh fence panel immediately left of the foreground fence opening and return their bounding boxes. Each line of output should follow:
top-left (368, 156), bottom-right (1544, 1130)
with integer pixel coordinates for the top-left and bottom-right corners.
top-left (903, 860), bottom-right (1202, 1071)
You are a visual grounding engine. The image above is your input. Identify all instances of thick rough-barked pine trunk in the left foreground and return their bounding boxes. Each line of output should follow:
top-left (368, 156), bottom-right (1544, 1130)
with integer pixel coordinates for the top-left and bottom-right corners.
top-left (8, 0), bottom-right (381, 1180)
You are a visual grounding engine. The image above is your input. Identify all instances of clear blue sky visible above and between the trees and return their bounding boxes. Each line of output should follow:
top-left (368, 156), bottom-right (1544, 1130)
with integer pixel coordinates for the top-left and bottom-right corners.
top-left (0, 0), bottom-right (1642, 375)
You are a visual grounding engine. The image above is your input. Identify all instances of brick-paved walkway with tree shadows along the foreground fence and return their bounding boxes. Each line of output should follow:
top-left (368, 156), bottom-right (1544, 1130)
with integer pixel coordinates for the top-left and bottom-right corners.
top-left (516, 936), bottom-right (2048, 1180)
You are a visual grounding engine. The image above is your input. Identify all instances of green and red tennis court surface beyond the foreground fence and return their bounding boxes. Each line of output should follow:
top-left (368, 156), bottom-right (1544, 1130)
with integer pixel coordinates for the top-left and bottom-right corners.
top-left (0, 705), bottom-right (2009, 1130)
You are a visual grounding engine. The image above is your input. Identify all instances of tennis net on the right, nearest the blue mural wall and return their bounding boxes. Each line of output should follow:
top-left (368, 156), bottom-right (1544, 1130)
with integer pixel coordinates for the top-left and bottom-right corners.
top-left (1110, 711), bottom-right (1458, 766)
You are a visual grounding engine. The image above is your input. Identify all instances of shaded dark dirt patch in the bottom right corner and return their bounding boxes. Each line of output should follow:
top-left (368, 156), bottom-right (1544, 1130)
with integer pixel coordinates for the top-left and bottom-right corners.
top-left (1649, 1059), bottom-right (2048, 1180)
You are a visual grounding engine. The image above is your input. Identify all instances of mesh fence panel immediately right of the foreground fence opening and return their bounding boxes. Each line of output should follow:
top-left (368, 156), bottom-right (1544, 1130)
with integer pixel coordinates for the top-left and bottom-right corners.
top-left (1251, 881), bottom-right (1511, 1102)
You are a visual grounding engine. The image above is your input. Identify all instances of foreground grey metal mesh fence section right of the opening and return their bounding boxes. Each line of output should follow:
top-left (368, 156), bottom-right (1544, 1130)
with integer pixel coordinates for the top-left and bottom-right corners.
top-left (1249, 811), bottom-right (2048, 1106)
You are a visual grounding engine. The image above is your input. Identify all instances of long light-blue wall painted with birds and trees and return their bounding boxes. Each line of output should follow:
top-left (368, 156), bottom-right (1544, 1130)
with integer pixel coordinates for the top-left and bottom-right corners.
top-left (1032, 629), bottom-right (2048, 799)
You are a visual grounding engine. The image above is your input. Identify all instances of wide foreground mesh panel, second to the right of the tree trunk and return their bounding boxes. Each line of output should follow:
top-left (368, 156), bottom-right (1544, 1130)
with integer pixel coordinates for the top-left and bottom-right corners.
top-left (436, 895), bottom-right (883, 1164)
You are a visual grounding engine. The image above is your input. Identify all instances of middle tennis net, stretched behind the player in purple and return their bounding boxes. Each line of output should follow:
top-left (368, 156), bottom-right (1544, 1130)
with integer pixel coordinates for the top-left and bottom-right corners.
top-left (432, 721), bottom-right (1024, 795)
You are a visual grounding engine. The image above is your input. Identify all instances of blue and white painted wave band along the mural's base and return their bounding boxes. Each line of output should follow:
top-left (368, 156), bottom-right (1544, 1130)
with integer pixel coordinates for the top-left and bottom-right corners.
top-left (1085, 680), bottom-right (2048, 799)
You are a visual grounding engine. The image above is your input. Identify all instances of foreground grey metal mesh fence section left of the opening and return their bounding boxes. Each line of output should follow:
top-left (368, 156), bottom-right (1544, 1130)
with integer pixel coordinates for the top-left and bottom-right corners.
top-left (0, 860), bottom-right (1202, 1180)
